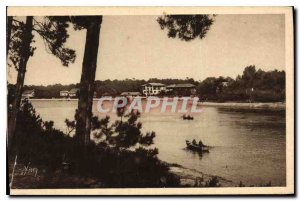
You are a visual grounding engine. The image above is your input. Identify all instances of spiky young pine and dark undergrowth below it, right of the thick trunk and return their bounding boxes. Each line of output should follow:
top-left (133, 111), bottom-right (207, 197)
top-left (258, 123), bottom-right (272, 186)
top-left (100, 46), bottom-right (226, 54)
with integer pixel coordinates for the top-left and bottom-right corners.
top-left (66, 109), bottom-right (180, 187)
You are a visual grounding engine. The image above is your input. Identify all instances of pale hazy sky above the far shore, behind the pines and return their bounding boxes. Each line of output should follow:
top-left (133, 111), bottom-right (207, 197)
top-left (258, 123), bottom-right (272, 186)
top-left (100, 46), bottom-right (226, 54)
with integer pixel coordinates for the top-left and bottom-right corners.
top-left (8, 15), bottom-right (285, 85)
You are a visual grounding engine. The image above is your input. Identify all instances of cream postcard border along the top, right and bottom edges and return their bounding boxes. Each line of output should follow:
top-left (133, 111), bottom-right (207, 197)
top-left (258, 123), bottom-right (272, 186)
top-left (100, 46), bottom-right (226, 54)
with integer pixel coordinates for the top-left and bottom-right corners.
top-left (7, 6), bottom-right (295, 195)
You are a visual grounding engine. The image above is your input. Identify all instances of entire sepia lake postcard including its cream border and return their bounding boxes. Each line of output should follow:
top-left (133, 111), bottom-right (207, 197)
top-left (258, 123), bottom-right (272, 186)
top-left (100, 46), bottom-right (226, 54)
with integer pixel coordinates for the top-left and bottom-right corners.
top-left (6, 7), bottom-right (295, 195)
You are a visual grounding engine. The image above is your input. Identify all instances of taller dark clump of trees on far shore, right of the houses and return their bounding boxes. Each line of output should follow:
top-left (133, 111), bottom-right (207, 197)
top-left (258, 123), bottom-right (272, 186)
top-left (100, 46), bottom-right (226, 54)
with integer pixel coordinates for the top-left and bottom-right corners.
top-left (197, 66), bottom-right (285, 102)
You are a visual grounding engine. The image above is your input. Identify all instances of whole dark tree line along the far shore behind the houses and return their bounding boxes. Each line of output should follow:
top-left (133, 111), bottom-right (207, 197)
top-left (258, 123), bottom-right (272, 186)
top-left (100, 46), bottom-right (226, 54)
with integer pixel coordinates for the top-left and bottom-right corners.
top-left (9, 66), bottom-right (285, 102)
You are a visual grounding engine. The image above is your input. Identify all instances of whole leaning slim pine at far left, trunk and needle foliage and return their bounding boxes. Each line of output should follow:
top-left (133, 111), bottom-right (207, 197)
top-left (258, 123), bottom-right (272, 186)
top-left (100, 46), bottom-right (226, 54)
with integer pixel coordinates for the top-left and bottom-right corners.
top-left (7, 16), bottom-right (76, 152)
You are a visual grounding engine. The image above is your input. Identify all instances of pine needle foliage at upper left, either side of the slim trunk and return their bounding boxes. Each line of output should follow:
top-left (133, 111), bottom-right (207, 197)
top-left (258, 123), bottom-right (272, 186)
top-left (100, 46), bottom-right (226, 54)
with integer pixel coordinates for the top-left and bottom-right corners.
top-left (8, 16), bottom-right (76, 70)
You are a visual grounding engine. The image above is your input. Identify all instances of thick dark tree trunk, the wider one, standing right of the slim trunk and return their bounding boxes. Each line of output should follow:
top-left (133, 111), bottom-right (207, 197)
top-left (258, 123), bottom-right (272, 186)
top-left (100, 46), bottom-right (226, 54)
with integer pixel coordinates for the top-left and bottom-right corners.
top-left (76, 16), bottom-right (102, 147)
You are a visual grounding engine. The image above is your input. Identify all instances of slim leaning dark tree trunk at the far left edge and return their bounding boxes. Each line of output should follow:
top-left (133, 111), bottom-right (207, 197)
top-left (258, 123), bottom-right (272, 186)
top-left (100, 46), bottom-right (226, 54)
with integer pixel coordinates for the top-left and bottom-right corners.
top-left (7, 16), bottom-right (33, 149)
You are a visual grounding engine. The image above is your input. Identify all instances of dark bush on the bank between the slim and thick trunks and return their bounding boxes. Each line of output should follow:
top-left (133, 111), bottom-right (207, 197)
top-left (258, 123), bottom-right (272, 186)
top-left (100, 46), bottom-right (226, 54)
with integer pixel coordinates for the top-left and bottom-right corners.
top-left (11, 100), bottom-right (72, 170)
